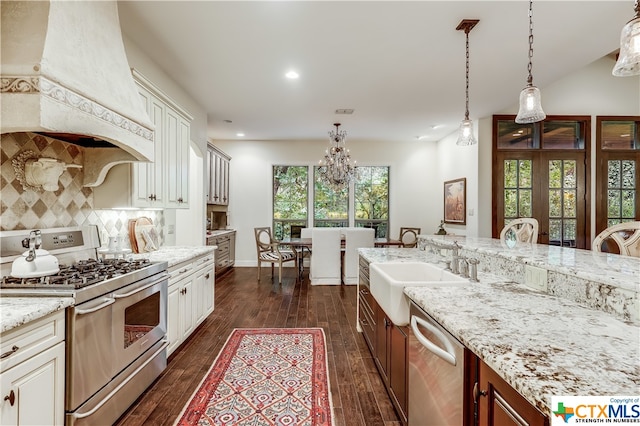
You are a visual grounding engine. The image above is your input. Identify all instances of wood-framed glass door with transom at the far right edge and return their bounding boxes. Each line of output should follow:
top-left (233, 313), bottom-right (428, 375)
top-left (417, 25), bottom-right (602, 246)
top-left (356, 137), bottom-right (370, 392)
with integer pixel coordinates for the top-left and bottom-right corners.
top-left (596, 116), bottom-right (640, 233)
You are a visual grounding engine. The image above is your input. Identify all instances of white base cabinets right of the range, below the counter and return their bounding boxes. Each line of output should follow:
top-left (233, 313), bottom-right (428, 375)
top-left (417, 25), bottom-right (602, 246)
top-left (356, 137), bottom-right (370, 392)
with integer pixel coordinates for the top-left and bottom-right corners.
top-left (167, 254), bottom-right (215, 356)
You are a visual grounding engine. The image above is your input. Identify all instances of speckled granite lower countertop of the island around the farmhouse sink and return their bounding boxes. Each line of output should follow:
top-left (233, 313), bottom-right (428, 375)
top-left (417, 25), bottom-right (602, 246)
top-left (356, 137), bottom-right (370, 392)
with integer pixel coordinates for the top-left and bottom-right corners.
top-left (359, 246), bottom-right (640, 417)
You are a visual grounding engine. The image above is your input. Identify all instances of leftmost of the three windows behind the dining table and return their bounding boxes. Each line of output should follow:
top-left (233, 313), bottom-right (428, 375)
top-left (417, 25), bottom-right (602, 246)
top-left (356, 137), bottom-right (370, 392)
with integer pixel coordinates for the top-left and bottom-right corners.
top-left (273, 166), bottom-right (309, 240)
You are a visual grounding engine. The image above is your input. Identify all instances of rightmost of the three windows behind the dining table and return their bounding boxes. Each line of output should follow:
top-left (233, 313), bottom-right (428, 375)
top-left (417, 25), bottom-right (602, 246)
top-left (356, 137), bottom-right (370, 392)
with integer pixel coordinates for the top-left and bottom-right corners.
top-left (354, 166), bottom-right (389, 238)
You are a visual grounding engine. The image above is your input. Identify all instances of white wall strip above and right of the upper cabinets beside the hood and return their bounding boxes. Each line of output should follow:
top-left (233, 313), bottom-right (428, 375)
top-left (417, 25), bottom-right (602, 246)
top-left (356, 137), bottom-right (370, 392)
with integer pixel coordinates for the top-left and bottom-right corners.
top-left (123, 34), bottom-right (207, 245)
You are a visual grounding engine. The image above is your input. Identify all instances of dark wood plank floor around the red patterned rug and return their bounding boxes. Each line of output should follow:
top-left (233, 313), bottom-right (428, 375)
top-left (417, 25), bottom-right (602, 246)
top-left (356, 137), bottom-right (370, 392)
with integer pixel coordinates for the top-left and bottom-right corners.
top-left (116, 268), bottom-right (400, 426)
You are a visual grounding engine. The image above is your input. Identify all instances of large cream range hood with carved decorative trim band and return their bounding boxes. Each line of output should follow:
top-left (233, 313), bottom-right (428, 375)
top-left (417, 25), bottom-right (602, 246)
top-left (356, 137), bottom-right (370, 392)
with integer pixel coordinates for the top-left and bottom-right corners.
top-left (0, 0), bottom-right (154, 186)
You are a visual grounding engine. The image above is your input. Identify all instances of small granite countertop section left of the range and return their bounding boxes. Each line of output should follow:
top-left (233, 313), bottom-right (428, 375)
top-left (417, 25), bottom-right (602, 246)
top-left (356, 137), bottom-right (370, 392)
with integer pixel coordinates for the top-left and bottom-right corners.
top-left (0, 297), bottom-right (73, 333)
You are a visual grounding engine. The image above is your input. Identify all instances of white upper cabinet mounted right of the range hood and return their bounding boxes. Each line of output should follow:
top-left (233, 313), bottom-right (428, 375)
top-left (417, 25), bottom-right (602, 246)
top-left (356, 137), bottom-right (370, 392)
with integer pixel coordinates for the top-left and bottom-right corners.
top-left (94, 70), bottom-right (193, 208)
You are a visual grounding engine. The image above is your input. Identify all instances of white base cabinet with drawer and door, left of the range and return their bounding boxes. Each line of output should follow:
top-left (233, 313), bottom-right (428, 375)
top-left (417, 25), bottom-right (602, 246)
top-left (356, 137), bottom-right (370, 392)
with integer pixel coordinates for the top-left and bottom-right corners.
top-left (0, 311), bottom-right (65, 425)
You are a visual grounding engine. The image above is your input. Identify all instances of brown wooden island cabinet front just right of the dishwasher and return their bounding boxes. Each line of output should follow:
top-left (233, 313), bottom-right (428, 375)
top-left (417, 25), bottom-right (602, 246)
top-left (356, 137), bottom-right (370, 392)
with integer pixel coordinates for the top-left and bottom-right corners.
top-left (477, 361), bottom-right (548, 426)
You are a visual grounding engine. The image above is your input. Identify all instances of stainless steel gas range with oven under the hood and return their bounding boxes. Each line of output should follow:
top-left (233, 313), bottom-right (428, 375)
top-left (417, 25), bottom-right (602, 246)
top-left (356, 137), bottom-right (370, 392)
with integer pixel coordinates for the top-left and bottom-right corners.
top-left (0, 226), bottom-right (168, 425)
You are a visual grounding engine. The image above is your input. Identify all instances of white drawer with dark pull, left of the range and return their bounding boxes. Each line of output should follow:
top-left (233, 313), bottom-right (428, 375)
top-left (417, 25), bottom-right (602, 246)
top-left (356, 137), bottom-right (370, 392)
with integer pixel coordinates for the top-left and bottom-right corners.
top-left (0, 310), bottom-right (65, 372)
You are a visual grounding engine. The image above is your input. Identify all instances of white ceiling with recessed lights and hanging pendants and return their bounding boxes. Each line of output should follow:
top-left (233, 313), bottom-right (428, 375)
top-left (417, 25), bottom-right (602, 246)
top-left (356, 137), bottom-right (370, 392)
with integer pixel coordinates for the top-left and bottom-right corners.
top-left (119, 0), bottom-right (633, 142)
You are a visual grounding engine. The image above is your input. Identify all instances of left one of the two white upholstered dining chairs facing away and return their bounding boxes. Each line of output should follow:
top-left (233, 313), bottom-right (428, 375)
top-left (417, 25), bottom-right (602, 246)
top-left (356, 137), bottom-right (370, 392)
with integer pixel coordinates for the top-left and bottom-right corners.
top-left (309, 228), bottom-right (340, 285)
